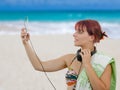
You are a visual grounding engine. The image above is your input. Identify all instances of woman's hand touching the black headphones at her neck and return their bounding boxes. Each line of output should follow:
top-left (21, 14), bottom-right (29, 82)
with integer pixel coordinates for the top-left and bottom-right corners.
top-left (80, 49), bottom-right (91, 66)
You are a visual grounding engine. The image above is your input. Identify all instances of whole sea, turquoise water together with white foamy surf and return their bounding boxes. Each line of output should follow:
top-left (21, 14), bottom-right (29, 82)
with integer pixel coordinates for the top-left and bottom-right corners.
top-left (0, 10), bottom-right (120, 39)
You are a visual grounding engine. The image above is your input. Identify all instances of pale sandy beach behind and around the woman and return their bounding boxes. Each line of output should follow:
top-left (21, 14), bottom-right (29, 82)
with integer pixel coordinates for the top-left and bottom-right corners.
top-left (0, 34), bottom-right (120, 90)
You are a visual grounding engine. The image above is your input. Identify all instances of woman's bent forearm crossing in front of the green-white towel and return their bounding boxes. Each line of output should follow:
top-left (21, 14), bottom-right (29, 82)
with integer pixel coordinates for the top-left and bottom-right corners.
top-left (85, 64), bottom-right (107, 90)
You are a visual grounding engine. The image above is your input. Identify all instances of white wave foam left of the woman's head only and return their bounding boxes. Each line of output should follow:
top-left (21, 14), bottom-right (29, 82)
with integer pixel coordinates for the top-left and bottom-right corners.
top-left (0, 21), bottom-right (74, 34)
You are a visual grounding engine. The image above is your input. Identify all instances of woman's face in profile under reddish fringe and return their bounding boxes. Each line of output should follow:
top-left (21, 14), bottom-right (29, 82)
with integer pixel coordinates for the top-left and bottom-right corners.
top-left (73, 26), bottom-right (92, 47)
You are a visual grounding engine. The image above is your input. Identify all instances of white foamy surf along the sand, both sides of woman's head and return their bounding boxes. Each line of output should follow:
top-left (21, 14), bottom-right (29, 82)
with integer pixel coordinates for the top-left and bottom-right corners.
top-left (0, 21), bottom-right (120, 38)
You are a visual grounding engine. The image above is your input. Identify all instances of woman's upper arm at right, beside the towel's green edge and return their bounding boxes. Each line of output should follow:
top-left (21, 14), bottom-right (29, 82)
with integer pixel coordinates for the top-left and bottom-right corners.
top-left (100, 64), bottom-right (112, 90)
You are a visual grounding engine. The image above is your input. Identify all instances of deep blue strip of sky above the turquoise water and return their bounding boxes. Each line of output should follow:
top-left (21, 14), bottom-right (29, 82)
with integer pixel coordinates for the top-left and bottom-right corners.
top-left (0, 0), bottom-right (120, 10)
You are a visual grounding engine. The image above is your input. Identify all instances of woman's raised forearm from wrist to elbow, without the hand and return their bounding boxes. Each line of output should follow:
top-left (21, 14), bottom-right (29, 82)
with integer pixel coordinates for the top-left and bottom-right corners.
top-left (24, 42), bottom-right (43, 71)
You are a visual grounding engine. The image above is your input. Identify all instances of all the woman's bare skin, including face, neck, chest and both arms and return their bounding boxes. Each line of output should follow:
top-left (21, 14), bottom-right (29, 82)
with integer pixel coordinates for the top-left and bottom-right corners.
top-left (21, 27), bottom-right (111, 90)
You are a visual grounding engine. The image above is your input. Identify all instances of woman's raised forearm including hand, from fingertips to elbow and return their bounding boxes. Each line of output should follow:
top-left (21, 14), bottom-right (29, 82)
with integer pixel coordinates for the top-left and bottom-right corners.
top-left (21, 28), bottom-right (43, 71)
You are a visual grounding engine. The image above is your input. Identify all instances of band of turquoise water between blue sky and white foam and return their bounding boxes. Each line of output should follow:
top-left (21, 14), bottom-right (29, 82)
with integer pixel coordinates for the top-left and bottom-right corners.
top-left (0, 11), bottom-right (120, 22)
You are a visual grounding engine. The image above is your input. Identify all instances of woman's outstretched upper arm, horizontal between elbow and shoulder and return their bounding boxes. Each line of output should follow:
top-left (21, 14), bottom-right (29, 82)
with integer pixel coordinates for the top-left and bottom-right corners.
top-left (38, 54), bottom-right (73, 72)
